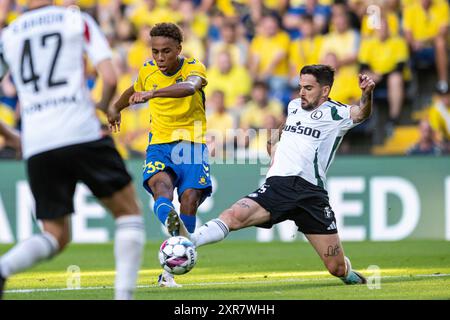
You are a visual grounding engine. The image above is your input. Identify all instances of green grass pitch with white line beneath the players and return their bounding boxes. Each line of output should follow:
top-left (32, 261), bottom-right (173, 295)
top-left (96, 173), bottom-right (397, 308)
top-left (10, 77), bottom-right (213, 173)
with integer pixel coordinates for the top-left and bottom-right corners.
top-left (0, 240), bottom-right (450, 300)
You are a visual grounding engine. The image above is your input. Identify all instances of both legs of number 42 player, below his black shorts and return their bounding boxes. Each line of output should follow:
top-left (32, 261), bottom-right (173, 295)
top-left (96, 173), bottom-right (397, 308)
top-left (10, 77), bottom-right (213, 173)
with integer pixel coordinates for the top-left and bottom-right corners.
top-left (0, 184), bottom-right (145, 299)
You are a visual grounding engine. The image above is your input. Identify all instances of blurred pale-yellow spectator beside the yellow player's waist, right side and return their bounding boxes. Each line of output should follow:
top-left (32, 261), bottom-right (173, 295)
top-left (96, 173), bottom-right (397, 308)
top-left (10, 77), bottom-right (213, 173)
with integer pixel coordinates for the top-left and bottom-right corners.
top-left (206, 90), bottom-right (236, 158)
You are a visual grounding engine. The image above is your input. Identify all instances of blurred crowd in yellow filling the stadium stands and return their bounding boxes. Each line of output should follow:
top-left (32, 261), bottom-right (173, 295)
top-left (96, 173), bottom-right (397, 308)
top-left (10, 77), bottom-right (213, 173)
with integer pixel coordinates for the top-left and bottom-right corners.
top-left (0, 0), bottom-right (450, 158)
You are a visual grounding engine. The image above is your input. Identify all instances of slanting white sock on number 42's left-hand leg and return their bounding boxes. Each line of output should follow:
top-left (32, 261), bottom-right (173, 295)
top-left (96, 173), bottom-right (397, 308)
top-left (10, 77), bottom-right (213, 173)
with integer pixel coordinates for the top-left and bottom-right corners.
top-left (0, 232), bottom-right (59, 278)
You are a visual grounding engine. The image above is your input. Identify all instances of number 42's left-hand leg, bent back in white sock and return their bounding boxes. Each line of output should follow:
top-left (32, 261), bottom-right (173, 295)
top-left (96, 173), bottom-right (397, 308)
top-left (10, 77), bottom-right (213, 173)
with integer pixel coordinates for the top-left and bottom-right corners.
top-left (0, 216), bottom-right (65, 299)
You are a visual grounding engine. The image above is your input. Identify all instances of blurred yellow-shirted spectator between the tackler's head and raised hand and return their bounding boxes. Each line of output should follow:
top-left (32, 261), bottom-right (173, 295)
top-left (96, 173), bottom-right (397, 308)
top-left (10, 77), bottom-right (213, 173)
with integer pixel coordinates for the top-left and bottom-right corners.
top-left (322, 53), bottom-right (361, 104)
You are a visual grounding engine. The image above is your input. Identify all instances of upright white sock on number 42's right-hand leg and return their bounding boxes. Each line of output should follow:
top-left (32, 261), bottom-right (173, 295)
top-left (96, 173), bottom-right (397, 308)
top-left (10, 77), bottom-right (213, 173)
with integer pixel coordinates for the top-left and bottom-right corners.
top-left (114, 215), bottom-right (145, 300)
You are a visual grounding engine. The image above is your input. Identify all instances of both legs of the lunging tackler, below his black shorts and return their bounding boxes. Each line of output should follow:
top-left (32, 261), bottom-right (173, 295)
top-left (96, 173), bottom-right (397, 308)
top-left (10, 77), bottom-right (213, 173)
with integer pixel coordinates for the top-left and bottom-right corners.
top-left (191, 198), bottom-right (366, 284)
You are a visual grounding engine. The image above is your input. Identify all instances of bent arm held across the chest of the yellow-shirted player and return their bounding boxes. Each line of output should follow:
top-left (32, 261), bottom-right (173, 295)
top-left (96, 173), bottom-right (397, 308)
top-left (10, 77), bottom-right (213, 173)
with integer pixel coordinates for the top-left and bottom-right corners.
top-left (129, 76), bottom-right (205, 104)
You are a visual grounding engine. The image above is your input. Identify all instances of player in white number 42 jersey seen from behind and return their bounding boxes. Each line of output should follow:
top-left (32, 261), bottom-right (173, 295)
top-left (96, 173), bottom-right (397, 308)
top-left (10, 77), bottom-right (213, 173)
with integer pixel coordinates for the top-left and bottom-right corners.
top-left (0, 0), bottom-right (145, 299)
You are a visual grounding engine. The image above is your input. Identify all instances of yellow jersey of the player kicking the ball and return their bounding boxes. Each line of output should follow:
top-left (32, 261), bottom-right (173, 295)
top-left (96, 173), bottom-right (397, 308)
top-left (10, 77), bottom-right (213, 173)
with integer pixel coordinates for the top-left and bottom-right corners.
top-left (134, 57), bottom-right (208, 144)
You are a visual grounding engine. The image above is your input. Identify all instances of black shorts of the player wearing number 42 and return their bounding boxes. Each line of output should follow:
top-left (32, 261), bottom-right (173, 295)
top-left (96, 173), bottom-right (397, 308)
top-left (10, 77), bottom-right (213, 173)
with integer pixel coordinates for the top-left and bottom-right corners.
top-left (27, 136), bottom-right (132, 219)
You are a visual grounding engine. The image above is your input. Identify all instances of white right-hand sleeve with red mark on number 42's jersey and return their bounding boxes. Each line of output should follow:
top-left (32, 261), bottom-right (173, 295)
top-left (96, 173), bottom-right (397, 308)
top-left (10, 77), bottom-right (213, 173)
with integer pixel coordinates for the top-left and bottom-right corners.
top-left (83, 13), bottom-right (112, 66)
